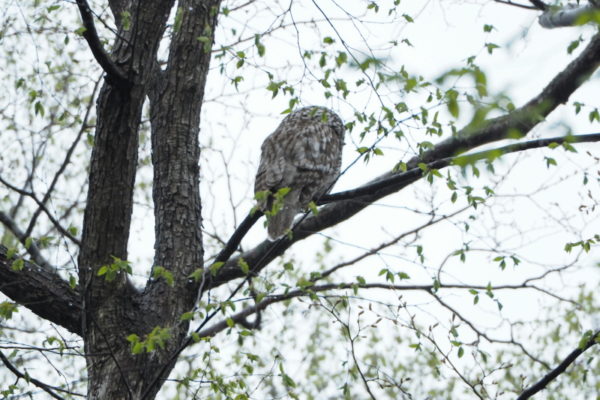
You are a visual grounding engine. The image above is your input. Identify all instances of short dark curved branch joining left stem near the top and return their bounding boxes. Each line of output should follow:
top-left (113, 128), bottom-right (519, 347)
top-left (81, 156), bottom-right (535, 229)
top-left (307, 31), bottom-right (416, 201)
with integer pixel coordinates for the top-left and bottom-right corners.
top-left (76, 0), bottom-right (131, 89)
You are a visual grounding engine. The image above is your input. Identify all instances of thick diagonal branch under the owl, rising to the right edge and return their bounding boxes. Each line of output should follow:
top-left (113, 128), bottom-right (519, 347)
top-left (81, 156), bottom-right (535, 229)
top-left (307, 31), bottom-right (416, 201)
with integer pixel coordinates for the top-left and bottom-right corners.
top-left (210, 34), bottom-right (600, 287)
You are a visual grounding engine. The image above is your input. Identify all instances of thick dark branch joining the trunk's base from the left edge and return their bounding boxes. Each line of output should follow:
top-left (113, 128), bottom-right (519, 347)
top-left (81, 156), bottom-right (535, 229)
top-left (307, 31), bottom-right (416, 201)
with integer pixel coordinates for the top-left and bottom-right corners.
top-left (0, 246), bottom-right (81, 335)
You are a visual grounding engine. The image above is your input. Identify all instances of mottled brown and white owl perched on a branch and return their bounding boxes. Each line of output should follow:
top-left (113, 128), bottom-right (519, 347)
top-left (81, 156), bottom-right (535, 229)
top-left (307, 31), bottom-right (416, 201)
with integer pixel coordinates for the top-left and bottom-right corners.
top-left (254, 106), bottom-right (344, 240)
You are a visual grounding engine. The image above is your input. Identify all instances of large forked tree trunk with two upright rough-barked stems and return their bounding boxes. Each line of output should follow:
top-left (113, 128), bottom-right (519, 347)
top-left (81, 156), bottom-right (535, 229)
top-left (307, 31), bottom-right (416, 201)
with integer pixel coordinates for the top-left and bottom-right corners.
top-left (79, 0), bottom-right (220, 399)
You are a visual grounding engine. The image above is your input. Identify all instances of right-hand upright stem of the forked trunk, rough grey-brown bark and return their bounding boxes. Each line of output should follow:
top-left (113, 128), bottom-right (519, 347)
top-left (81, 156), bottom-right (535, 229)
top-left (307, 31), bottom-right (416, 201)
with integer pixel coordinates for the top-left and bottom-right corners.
top-left (145, 0), bottom-right (220, 318)
